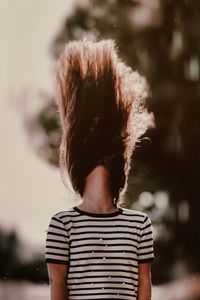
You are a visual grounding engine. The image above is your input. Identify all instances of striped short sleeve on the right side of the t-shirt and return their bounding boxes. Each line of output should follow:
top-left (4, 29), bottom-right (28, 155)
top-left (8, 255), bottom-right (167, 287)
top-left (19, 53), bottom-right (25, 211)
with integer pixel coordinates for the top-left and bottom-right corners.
top-left (138, 215), bottom-right (154, 263)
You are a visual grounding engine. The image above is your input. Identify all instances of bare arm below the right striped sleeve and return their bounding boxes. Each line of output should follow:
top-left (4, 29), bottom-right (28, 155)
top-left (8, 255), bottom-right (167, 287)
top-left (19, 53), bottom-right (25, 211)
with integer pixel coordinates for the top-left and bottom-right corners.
top-left (137, 263), bottom-right (151, 300)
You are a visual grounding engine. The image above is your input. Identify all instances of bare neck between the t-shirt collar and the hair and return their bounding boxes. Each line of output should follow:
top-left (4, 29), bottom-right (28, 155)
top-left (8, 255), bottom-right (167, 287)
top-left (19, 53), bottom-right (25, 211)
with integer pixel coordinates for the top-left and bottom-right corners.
top-left (79, 165), bottom-right (116, 213)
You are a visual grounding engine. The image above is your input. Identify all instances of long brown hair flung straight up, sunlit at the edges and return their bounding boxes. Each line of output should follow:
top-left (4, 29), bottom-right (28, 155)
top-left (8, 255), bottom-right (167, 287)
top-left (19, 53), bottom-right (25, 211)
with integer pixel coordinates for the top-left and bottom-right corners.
top-left (56, 40), bottom-right (153, 204)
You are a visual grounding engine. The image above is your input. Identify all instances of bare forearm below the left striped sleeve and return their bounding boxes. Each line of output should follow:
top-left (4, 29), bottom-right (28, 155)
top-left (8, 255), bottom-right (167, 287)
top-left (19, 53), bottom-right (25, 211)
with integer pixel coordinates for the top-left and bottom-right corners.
top-left (47, 263), bottom-right (68, 300)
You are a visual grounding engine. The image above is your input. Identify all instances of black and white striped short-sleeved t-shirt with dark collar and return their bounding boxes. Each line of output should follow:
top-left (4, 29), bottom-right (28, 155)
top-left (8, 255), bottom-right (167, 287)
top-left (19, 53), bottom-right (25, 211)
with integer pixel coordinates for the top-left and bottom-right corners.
top-left (45, 206), bottom-right (154, 300)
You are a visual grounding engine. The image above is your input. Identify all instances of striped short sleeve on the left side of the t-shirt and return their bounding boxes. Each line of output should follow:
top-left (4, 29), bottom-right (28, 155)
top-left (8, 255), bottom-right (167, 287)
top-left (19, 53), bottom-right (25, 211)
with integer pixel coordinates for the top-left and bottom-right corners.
top-left (45, 215), bottom-right (69, 264)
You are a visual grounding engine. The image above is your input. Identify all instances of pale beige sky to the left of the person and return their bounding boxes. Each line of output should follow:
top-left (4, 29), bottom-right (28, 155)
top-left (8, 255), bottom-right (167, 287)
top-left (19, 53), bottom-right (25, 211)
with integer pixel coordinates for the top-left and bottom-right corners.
top-left (0, 0), bottom-right (75, 245)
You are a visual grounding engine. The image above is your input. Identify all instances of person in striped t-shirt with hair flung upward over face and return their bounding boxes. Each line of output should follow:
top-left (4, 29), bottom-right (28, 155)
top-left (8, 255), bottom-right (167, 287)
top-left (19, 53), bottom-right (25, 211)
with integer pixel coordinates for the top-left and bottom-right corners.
top-left (45, 40), bottom-right (154, 300)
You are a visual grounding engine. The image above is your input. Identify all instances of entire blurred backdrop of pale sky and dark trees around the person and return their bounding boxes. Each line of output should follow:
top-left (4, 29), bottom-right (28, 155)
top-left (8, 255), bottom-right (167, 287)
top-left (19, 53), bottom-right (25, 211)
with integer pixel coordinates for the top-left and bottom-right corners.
top-left (0, 0), bottom-right (200, 300)
